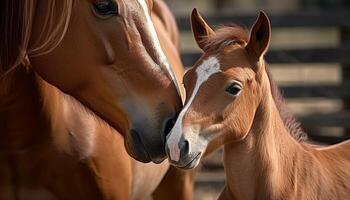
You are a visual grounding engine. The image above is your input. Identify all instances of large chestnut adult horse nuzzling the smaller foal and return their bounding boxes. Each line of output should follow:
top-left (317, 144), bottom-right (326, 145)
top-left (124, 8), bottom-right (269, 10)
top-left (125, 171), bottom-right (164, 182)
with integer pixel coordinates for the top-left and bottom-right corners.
top-left (0, 0), bottom-right (191, 199)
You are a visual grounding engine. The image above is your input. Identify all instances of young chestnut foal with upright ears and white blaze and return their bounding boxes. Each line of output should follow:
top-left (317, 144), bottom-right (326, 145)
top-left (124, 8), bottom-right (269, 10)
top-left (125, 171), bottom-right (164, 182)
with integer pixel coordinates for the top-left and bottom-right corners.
top-left (166, 10), bottom-right (350, 200)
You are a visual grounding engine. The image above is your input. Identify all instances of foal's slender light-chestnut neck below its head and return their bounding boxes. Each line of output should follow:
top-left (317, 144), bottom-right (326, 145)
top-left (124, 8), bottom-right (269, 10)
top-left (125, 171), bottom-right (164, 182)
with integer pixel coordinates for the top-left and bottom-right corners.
top-left (224, 71), bottom-right (299, 199)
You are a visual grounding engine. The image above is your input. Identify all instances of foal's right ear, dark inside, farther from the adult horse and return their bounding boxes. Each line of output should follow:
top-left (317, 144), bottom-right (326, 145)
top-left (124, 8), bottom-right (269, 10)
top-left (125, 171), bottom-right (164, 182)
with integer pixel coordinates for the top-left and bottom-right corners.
top-left (246, 11), bottom-right (271, 61)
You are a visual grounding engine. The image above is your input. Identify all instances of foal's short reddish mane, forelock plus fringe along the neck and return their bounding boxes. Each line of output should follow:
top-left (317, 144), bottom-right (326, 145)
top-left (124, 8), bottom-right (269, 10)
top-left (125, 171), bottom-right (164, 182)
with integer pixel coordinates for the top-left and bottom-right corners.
top-left (201, 25), bottom-right (307, 142)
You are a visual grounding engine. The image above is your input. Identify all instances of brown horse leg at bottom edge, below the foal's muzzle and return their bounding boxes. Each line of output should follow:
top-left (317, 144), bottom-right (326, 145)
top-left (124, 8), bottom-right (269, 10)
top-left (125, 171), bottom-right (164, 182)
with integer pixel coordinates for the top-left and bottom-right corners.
top-left (153, 166), bottom-right (196, 200)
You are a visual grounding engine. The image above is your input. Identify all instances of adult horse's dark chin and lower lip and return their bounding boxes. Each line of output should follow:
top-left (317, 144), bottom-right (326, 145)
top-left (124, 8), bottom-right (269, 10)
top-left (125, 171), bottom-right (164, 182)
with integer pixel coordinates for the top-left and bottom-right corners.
top-left (125, 130), bottom-right (166, 164)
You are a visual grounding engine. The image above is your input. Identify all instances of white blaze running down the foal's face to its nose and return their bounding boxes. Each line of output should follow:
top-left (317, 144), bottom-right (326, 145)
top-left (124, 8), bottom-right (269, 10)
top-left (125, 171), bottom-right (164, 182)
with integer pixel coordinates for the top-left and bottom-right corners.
top-left (167, 57), bottom-right (221, 162)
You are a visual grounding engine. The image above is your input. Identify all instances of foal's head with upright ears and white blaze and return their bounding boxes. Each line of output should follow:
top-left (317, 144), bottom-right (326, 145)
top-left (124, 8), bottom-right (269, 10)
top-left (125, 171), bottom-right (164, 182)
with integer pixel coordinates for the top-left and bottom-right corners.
top-left (166, 10), bottom-right (270, 168)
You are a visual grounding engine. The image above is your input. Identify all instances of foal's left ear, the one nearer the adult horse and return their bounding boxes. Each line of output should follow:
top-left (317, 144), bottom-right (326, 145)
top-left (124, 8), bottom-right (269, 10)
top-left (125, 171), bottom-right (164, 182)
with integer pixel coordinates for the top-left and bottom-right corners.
top-left (191, 8), bottom-right (215, 50)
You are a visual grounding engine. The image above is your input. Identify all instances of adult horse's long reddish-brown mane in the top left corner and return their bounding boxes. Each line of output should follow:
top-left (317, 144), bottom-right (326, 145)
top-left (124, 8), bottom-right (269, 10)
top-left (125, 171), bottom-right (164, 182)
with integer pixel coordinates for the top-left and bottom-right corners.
top-left (0, 0), bottom-right (73, 77)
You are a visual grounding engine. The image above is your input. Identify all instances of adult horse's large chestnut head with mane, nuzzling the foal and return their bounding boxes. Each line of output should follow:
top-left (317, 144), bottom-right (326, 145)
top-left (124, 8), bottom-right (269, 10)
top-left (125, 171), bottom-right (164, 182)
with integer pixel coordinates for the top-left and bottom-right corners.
top-left (0, 0), bottom-right (182, 162)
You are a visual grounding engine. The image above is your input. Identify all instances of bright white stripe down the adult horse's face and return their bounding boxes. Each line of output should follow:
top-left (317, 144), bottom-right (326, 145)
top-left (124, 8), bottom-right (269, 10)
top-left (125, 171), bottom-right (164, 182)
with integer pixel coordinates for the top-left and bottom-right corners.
top-left (138, 0), bottom-right (181, 96)
